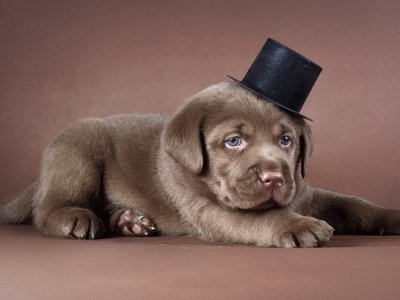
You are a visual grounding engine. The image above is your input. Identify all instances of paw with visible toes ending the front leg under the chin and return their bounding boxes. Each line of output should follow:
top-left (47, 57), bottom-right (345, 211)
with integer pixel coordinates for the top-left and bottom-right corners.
top-left (278, 217), bottom-right (334, 248)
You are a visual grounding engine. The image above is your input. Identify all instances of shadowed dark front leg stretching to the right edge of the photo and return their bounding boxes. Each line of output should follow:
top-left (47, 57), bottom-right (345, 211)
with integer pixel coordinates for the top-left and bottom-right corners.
top-left (310, 189), bottom-right (400, 235)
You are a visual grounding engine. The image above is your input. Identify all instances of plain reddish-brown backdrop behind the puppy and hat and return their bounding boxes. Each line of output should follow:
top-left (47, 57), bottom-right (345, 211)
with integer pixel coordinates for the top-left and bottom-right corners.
top-left (0, 0), bottom-right (400, 208)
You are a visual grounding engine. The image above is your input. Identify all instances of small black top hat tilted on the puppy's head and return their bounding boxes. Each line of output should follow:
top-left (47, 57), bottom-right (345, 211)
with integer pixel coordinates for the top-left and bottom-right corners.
top-left (228, 39), bottom-right (322, 120)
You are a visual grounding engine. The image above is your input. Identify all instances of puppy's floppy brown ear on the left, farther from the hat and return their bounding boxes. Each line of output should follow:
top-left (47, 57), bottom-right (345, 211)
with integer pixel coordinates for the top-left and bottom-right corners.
top-left (162, 101), bottom-right (205, 174)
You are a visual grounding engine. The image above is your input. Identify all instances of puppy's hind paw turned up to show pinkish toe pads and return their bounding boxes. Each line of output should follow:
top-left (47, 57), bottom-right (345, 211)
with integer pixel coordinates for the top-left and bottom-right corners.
top-left (110, 208), bottom-right (157, 236)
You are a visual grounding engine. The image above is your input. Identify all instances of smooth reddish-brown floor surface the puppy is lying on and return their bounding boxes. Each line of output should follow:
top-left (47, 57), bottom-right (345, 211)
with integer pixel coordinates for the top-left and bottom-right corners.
top-left (0, 225), bottom-right (400, 300)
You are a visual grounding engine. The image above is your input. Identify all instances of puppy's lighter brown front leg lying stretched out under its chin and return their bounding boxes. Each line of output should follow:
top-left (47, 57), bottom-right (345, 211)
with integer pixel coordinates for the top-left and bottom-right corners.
top-left (173, 197), bottom-right (333, 248)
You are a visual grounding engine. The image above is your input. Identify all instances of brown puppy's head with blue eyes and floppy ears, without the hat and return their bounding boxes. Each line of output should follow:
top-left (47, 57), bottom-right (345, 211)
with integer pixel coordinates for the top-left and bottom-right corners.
top-left (162, 82), bottom-right (312, 209)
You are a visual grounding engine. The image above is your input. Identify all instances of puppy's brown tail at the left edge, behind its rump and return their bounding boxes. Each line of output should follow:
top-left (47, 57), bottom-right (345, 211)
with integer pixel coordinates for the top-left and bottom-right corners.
top-left (0, 181), bottom-right (37, 224)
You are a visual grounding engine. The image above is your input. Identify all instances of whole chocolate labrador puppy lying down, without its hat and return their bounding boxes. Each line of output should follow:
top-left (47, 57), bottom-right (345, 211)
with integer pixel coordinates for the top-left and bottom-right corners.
top-left (0, 82), bottom-right (400, 247)
